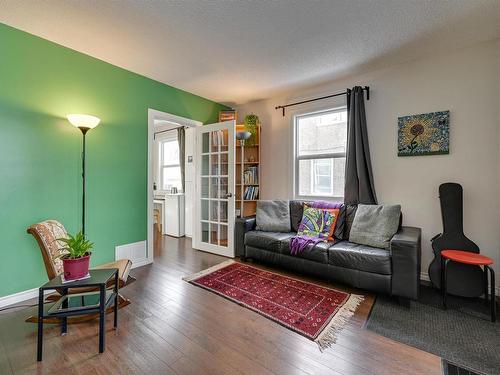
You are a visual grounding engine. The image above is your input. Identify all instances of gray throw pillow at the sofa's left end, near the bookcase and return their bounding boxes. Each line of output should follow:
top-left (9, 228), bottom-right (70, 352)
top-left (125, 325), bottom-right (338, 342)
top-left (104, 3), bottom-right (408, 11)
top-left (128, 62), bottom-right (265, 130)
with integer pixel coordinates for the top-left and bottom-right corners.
top-left (256, 200), bottom-right (291, 232)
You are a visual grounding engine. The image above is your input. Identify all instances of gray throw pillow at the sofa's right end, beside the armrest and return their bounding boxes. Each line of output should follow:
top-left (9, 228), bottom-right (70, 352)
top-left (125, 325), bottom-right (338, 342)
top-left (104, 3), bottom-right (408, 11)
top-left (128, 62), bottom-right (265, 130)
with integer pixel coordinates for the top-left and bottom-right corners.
top-left (349, 204), bottom-right (401, 249)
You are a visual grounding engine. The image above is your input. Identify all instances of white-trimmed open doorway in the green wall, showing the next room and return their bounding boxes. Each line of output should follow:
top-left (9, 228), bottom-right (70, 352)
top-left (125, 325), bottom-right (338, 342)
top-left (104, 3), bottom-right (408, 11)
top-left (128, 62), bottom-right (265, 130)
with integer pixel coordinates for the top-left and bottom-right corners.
top-left (147, 109), bottom-right (202, 262)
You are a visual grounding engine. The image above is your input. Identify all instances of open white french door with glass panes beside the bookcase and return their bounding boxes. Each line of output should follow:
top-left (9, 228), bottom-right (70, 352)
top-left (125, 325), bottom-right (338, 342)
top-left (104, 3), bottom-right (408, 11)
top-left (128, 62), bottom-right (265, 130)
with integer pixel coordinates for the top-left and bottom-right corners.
top-left (193, 121), bottom-right (236, 257)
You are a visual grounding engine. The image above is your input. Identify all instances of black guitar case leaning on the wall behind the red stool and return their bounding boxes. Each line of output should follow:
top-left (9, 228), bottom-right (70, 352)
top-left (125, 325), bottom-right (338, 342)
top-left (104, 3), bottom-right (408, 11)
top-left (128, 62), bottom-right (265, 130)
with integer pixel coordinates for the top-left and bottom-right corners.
top-left (429, 182), bottom-right (483, 297)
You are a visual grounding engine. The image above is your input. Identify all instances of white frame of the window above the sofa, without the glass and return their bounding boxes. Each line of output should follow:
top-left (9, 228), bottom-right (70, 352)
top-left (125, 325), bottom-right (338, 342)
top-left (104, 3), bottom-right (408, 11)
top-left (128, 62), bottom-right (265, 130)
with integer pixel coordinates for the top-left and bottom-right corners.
top-left (293, 105), bottom-right (347, 201)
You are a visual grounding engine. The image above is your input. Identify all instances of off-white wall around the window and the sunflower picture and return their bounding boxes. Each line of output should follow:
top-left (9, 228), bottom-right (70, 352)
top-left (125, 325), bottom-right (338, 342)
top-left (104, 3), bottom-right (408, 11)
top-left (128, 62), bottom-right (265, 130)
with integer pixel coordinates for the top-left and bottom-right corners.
top-left (237, 40), bottom-right (500, 285)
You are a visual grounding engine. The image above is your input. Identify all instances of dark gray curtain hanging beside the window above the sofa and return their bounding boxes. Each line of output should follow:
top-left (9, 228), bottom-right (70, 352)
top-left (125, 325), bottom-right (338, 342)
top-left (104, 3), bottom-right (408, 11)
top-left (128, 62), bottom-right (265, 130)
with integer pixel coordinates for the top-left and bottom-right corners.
top-left (344, 86), bottom-right (377, 204)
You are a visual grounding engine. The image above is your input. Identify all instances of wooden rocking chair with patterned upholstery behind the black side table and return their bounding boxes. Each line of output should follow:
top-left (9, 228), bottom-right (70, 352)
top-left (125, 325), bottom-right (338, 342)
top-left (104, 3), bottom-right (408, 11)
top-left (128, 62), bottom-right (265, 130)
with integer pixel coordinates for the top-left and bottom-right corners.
top-left (26, 220), bottom-right (135, 324)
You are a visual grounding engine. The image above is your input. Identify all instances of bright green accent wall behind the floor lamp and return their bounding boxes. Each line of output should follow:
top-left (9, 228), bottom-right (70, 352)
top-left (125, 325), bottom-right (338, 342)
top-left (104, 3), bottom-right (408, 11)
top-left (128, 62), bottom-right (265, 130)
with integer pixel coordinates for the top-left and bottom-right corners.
top-left (0, 24), bottom-right (225, 297)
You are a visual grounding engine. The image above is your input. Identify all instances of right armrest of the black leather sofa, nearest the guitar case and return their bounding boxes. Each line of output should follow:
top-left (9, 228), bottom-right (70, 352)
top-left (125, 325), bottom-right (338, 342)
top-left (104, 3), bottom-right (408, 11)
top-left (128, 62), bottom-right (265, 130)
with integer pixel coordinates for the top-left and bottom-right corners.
top-left (390, 227), bottom-right (422, 300)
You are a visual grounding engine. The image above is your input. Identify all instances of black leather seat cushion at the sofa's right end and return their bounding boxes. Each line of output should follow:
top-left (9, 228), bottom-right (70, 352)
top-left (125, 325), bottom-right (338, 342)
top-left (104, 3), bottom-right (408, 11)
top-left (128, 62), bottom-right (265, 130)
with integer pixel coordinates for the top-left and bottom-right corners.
top-left (328, 241), bottom-right (392, 275)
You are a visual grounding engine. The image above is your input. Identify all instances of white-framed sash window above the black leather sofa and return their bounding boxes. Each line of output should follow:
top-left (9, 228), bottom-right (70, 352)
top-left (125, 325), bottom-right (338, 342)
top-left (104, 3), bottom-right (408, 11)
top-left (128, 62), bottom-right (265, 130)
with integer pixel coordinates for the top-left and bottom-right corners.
top-left (294, 108), bottom-right (347, 198)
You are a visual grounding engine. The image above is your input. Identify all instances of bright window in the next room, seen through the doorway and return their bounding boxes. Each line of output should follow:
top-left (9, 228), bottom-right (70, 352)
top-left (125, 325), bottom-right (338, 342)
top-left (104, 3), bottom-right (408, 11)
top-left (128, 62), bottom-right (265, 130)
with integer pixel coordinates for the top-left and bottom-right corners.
top-left (159, 137), bottom-right (182, 191)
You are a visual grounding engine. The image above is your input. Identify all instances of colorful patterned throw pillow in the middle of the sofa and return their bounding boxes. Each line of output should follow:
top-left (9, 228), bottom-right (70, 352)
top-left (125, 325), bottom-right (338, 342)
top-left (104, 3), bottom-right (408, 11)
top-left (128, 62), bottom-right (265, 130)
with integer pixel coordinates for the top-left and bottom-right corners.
top-left (297, 204), bottom-right (339, 241)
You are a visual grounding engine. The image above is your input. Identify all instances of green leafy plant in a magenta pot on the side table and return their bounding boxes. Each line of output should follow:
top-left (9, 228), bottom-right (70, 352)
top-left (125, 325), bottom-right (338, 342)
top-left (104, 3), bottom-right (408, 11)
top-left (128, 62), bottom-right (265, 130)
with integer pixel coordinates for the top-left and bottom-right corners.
top-left (57, 231), bottom-right (94, 280)
